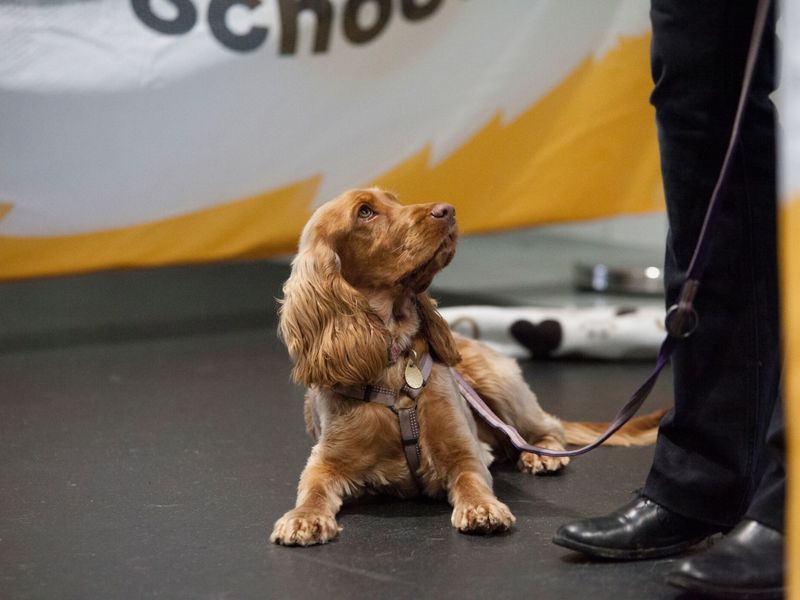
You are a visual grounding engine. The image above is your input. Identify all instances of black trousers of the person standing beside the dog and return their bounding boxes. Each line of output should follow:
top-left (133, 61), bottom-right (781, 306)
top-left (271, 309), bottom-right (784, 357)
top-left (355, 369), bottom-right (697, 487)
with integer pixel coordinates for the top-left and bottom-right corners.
top-left (643, 0), bottom-right (785, 530)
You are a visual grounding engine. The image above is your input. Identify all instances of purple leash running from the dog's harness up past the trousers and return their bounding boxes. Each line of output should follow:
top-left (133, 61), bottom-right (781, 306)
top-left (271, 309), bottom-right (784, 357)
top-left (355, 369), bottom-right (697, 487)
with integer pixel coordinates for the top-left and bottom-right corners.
top-left (450, 0), bottom-right (770, 457)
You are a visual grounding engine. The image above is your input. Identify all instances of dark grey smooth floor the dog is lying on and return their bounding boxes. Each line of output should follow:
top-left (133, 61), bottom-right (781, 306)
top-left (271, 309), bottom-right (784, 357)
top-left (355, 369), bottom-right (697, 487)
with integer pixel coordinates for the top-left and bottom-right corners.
top-left (0, 260), bottom-right (692, 600)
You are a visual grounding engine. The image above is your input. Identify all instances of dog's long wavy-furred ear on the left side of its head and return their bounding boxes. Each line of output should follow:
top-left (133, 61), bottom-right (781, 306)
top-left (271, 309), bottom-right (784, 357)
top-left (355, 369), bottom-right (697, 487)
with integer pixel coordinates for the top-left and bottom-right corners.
top-left (279, 242), bottom-right (389, 387)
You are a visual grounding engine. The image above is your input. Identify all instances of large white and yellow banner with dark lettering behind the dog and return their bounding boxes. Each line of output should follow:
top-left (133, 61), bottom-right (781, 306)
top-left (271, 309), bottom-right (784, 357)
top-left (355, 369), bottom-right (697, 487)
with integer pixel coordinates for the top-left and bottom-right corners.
top-left (0, 0), bottom-right (663, 280)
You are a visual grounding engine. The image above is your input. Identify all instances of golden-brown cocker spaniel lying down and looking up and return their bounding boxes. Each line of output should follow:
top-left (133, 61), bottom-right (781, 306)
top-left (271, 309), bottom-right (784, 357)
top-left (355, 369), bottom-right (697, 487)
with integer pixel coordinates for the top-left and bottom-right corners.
top-left (271, 188), bottom-right (661, 546)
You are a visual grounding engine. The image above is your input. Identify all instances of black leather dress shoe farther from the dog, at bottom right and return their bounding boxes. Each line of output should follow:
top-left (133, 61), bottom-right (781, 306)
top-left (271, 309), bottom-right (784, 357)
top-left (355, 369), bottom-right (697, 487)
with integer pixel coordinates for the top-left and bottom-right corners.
top-left (667, 521), bottom-right (784, 598)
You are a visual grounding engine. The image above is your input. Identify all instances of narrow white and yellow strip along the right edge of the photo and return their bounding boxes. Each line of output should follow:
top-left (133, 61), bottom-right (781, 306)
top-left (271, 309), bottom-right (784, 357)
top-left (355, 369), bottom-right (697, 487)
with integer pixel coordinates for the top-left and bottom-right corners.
top-left (778, 0), bottom-right (800, 600)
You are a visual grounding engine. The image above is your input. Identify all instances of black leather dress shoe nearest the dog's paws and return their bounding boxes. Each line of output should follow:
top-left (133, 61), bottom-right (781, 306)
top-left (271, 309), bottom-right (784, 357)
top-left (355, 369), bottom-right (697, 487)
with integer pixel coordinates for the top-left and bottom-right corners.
top-left (553, 496), bottom-right (719, 560)
